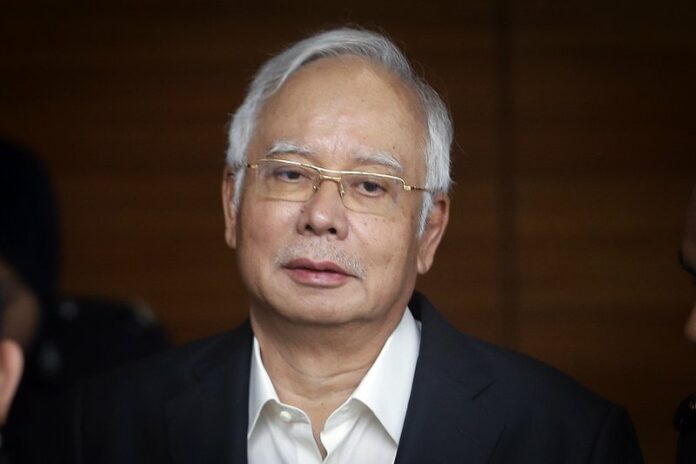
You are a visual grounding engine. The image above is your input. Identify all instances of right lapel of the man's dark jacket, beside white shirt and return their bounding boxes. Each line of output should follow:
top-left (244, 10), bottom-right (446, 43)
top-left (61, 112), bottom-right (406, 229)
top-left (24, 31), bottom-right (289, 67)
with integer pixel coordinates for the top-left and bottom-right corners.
top-left (395, 293), bottom-right (504, 464)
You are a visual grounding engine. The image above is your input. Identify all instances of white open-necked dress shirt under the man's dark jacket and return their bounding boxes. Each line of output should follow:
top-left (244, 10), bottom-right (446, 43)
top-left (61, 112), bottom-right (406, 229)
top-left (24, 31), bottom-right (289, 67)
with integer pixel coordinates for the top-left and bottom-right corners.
top-left (247, 308), bottom-right (420, 464)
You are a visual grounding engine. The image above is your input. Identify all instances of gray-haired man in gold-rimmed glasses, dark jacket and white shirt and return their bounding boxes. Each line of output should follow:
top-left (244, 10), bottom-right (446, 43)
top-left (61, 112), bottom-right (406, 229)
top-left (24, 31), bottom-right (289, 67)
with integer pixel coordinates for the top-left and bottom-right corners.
top-left (73, 29), bottom-right (641, 464)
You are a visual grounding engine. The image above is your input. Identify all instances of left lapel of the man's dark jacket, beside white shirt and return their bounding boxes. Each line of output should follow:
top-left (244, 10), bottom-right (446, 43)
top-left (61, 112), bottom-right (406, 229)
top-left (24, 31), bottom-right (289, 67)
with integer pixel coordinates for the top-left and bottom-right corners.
top-left (165, 322), bottom-right (252, 464)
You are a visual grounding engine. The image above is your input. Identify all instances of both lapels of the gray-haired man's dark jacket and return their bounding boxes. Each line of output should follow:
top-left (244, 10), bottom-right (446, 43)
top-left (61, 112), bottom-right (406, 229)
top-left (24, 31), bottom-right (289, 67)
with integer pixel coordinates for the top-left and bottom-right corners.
top-left (165, 293), bottom-right (504, 464)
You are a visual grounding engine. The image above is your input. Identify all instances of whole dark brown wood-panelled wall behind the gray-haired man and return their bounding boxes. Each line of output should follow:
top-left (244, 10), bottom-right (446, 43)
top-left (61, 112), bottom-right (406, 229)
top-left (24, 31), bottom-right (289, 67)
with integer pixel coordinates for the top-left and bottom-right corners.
top-left (0, 0), bottom-right (696, 463)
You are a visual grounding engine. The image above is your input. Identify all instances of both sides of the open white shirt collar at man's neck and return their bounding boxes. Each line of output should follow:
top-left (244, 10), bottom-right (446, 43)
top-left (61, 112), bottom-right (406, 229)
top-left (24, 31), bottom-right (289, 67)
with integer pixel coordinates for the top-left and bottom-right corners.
top-left (247, 308), bottom-right (420, 444)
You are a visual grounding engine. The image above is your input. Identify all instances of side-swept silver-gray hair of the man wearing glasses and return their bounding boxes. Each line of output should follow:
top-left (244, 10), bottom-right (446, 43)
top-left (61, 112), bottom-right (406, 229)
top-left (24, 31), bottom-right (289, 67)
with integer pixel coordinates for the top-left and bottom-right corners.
top-left (227, 28), bottom-right (452, 235)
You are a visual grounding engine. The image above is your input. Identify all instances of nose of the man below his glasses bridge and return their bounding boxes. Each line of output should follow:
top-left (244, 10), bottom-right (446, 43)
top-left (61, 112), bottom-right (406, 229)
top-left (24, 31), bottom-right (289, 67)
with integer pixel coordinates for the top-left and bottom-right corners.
top-left (297, 177), bottom-right (348, 240)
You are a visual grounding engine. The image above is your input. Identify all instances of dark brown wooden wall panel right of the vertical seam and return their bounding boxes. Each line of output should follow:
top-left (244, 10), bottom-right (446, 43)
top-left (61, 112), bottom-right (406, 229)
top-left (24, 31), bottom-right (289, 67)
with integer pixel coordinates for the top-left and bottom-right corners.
top-left (513, 2), bottom-right (696, 462)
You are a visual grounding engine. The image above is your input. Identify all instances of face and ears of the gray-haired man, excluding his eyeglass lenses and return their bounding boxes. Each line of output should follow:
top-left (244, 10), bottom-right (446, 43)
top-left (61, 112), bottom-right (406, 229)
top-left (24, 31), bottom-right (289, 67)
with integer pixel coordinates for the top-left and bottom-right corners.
top-left (223, 57), bottom-right (448, 325)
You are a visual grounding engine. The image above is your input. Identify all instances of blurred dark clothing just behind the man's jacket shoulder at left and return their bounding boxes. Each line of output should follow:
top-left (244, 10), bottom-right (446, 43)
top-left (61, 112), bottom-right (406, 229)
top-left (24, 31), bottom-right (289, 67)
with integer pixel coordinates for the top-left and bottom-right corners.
top-left (2, 298), bottom-right (167, 464)
